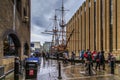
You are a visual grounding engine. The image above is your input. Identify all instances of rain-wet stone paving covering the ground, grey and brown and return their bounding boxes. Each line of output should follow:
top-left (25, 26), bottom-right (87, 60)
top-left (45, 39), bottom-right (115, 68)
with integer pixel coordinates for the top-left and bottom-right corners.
top-left (5, 59), bottom-right (120, 80)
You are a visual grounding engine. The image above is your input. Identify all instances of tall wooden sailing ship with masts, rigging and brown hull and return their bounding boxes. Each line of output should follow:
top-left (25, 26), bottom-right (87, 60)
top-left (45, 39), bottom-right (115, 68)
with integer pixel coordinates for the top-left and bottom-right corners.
top-left (44, 0), bottom-right (74, 53)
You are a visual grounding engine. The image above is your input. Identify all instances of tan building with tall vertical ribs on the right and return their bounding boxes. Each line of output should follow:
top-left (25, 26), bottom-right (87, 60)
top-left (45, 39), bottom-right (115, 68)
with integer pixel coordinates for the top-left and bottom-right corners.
top-left (66, 0), bottom-right (120, 56)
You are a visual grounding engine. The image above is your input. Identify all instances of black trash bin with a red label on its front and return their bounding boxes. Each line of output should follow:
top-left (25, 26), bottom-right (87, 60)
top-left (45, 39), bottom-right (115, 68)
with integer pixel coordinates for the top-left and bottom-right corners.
top-left (25, 61), bottom-right (38, 79)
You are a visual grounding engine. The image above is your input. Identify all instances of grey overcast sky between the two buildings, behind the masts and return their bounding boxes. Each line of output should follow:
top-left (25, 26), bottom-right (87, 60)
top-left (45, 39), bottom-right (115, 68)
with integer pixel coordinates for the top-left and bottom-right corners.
top-left (31, 0), bottom-right (85, 44)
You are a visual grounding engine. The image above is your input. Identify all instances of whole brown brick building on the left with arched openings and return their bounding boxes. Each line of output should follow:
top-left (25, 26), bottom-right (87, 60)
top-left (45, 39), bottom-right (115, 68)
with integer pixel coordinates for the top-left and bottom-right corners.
top-left (0, 0), bottom-right (31, 73)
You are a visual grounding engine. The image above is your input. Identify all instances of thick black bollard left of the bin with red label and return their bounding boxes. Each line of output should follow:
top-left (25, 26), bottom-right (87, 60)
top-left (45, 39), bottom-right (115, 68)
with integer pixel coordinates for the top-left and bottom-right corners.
top-left (14, 58), bottom-right (19, 80)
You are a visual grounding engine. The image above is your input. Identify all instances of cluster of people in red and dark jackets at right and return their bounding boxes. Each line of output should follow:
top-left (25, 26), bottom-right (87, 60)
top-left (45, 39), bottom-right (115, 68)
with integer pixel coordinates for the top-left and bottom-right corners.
top-left (80, 49), bottom-right (115, 70)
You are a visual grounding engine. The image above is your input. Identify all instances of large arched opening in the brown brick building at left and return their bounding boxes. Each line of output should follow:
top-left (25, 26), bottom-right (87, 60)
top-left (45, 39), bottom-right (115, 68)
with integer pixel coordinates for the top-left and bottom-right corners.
top-left (2, 30), bottom-right (21, 57)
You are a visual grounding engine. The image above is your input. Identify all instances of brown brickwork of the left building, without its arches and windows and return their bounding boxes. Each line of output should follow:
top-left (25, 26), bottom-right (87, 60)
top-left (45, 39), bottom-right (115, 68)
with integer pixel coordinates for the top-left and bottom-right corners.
top-left (0, 0), bottom-right (30, 65)
